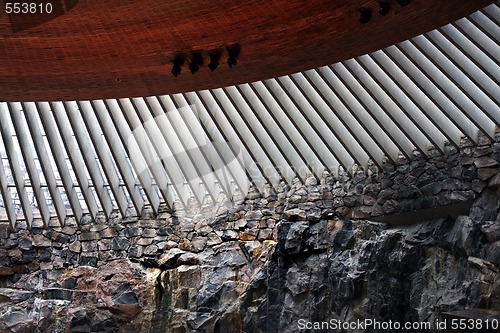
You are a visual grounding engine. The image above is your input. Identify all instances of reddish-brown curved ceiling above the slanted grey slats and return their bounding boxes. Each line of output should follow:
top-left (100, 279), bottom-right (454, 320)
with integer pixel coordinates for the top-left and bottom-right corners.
top-left (0, 0), bottom-right (494, 101)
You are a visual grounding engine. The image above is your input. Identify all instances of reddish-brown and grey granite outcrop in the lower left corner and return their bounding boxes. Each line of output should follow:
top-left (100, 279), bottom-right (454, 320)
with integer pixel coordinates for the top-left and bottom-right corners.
top-left (0, 260), bottom-right (150, 332)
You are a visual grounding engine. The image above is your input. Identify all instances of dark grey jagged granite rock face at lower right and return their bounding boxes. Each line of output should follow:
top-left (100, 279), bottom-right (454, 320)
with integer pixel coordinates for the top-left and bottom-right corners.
top-left (240, 190), bottom-right (500, 332)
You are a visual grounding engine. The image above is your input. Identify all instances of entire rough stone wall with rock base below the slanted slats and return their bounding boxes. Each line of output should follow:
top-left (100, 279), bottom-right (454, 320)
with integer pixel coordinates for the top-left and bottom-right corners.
top-left (0, 135), bottom-right (500, 333)
